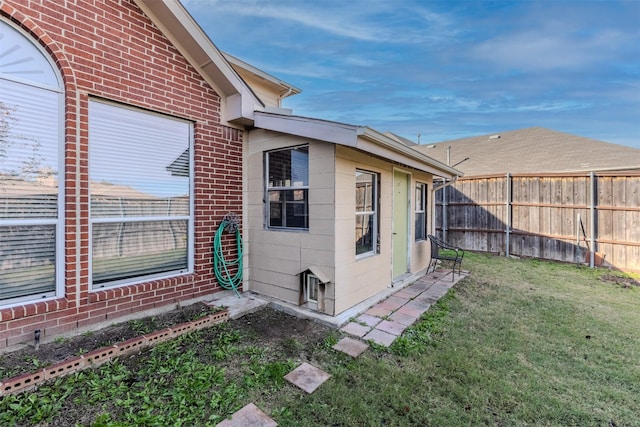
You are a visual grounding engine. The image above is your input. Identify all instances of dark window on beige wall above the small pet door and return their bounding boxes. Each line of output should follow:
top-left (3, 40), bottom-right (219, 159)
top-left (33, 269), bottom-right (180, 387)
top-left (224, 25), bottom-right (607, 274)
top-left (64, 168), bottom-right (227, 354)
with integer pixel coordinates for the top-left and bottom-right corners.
top-left (265, 146), bottom-right (309, 229)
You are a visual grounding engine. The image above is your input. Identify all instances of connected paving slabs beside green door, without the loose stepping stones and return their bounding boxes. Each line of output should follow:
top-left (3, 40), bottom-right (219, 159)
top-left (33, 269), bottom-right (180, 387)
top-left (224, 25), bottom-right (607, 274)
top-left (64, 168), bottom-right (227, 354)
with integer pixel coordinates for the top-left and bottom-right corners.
top-left (340, 270), bottom-right (469, 347)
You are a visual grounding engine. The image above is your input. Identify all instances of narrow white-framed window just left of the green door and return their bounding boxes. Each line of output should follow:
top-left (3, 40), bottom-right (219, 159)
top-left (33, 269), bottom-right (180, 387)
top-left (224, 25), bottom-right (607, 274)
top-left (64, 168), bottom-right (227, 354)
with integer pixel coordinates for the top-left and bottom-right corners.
top-left (355, 170), bottom-right (378, 256)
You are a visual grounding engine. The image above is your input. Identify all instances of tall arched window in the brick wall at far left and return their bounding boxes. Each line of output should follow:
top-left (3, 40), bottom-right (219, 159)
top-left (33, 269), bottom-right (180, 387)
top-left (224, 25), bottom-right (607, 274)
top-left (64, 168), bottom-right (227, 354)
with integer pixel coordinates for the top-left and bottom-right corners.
top-left (0, 20), bottom-right (64, 306)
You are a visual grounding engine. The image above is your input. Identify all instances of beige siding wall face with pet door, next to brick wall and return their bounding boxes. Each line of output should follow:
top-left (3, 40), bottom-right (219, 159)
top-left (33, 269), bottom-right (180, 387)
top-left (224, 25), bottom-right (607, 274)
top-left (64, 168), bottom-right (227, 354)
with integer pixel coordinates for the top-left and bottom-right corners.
top-left (245, 130), bottom-right (335, 314)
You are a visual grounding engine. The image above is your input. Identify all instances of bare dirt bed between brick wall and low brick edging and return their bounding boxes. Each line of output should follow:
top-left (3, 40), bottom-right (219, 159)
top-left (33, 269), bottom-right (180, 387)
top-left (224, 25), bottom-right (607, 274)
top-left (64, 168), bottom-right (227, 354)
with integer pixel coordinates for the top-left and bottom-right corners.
top-left (0, 303), bottom-right (218, 381)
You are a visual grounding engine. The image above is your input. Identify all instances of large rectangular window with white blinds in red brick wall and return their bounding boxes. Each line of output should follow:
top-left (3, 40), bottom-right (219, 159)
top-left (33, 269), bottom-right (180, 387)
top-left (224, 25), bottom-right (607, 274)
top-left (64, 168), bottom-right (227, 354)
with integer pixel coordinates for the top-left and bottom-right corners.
top-left (89, 101), bottom-right (193, 289)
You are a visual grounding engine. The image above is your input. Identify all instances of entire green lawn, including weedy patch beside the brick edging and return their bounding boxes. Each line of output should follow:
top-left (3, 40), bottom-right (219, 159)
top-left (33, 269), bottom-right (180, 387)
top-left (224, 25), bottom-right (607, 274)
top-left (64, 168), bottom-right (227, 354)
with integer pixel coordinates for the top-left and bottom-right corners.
top-left (0, 254), bottom-right (640, 427)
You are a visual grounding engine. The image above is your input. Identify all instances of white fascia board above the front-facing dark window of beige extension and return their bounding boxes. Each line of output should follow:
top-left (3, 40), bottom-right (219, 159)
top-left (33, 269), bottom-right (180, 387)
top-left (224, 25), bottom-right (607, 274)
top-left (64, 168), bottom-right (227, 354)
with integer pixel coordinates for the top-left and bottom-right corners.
top-left (254, 111), bottom-right (358, 147)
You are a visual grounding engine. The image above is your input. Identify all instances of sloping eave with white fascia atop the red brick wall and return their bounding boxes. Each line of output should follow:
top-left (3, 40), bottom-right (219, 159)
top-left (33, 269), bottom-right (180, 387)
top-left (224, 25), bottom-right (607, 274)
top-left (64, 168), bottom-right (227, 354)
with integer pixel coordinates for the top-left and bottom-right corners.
top-left (134, 0), bottom-right (264, 124)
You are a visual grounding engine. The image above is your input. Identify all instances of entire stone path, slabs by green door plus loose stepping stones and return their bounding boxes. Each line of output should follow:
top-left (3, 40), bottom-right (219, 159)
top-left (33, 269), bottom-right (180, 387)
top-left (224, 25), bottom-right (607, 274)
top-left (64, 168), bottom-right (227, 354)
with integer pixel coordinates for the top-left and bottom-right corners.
top-left (216, 270), bottom-right (469, 427)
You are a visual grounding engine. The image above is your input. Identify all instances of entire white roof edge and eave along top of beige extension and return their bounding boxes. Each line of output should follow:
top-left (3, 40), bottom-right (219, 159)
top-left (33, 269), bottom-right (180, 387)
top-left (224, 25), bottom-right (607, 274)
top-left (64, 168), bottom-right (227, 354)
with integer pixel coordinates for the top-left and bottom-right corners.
top-left (255, 112), bottom-right (462, 179)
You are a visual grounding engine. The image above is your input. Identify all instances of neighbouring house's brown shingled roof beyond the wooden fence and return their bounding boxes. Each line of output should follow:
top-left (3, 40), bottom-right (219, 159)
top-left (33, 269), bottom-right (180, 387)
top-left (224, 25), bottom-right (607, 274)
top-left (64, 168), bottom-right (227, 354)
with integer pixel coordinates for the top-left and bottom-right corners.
top-left (413, 127), bottom-right (640, 177)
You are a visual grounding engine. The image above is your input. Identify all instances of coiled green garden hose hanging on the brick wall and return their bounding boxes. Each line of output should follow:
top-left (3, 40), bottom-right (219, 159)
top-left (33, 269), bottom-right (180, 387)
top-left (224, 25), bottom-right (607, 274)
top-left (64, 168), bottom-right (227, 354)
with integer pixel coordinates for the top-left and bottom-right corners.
top-left (213, 212), bottom-right (243, 298)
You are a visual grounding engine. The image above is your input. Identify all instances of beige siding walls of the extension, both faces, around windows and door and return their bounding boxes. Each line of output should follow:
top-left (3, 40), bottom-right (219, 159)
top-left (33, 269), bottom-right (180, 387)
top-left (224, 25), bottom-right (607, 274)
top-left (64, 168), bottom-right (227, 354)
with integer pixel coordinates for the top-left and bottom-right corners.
top-left (245, 135), bottom-right (433, 315)
